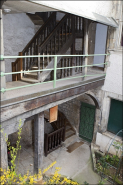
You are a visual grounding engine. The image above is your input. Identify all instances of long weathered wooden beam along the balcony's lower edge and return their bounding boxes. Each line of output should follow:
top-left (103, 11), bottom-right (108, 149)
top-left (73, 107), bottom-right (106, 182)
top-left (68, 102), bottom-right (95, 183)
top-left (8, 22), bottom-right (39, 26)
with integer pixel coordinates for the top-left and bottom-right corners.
top-left (1, 77), bottom-right (104, 122)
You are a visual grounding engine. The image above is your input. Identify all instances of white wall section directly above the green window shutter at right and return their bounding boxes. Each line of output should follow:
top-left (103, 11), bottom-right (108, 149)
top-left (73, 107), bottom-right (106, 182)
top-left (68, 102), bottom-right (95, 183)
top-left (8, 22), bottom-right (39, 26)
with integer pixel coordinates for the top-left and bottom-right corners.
top-left (102, 51), bottom-right (123, 95)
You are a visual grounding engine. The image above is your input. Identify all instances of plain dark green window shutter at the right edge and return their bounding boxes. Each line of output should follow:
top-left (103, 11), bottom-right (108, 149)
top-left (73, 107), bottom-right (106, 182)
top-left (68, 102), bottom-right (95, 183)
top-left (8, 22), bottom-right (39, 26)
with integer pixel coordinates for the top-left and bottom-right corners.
top-left (107, 99), bottom-right (123, 136)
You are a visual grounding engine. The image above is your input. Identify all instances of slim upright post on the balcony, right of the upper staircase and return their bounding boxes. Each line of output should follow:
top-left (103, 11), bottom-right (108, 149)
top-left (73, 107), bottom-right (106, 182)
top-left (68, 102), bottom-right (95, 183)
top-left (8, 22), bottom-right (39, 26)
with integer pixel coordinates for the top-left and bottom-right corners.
top-left (82, 19), bottom-right (88, 80)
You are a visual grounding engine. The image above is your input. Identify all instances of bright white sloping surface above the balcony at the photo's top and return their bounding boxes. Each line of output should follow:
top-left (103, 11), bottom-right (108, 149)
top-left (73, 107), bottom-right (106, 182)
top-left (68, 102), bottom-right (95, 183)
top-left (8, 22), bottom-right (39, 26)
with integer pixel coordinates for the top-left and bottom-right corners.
top-left (37, 1), bottom-right (116, 18)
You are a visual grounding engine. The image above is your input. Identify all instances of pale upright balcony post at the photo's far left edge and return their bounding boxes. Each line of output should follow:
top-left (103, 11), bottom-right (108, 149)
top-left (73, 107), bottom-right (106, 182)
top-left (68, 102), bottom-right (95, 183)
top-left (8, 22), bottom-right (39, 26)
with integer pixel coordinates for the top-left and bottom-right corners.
top-left (0, 9), bottom-right (6, 100)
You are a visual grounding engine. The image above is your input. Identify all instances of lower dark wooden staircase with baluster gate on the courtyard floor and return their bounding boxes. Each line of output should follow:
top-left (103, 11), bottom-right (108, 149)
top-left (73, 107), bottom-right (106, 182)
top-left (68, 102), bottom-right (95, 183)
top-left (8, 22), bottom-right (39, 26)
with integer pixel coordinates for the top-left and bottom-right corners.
top-left (44, 111), bottom-right (76, 156)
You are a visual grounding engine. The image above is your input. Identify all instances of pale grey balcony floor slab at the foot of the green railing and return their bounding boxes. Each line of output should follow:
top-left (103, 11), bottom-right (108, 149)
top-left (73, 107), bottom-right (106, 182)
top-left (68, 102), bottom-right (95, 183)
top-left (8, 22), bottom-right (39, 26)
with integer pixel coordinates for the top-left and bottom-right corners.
top-left (6, 72), bottom-right (105, 99)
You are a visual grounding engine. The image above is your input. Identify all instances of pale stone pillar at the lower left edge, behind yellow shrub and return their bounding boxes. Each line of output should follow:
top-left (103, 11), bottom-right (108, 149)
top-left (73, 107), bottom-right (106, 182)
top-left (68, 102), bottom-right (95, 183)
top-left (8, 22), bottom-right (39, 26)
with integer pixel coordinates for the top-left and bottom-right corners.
top-left (0, 133), bottom-right (8, 170)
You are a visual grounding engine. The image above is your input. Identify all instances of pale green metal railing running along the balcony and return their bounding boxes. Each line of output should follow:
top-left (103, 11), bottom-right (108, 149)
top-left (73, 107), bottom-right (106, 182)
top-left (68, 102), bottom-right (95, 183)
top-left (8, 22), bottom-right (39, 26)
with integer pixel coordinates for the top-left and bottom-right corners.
top-left (0, 54), bottom-right (107, 93)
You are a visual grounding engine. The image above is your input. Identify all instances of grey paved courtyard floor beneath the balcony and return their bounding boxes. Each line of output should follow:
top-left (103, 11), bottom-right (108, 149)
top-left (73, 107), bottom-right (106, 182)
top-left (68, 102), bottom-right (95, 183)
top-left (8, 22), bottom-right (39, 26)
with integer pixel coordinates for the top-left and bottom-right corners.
top-left (16, 135), bottom-right (104, 184)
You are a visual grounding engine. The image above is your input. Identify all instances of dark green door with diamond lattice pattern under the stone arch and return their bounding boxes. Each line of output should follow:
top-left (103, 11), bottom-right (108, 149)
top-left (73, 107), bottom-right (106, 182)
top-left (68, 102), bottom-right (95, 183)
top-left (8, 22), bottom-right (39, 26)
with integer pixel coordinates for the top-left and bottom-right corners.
top-left (79, 103), bottom-right (96, 142)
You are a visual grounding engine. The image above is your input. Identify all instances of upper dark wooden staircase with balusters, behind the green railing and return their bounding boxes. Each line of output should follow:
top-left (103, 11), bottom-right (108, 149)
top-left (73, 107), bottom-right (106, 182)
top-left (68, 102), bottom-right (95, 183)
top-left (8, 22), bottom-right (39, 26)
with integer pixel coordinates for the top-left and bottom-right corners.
top-left (12, 12), bottom-right (83, 83)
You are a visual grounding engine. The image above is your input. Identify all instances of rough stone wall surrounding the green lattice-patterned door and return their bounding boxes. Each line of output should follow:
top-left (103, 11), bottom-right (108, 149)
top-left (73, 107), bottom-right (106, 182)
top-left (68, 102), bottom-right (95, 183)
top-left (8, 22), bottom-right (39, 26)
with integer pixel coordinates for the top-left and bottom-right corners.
top-left (59, 87), bottom-right (103, 141)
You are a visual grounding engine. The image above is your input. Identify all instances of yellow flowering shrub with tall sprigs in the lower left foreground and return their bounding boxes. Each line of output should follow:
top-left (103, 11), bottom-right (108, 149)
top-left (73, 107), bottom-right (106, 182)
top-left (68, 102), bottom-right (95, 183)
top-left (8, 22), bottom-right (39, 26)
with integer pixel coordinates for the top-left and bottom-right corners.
top-left (0, 120), bottom-right (79, 185)
